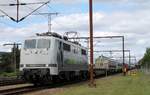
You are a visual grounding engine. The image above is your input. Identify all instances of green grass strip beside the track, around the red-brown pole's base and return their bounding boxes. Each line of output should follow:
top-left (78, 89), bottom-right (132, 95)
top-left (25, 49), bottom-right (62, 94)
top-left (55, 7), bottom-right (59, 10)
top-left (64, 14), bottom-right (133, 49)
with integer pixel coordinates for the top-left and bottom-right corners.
top-left (55, 73), bottom-right (150, 95)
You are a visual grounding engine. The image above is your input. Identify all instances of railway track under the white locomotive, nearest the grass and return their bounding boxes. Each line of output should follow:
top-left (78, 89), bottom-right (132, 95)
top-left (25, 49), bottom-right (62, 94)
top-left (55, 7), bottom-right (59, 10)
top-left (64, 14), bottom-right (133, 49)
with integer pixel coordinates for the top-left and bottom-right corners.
top-left (0, 74), bottom-right (122, 95)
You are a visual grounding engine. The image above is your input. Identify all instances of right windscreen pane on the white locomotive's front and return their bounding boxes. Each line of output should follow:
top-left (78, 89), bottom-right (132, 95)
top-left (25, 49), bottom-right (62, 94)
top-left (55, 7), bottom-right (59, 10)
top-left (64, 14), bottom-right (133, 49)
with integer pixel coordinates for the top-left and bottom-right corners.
top-left (37, 39), bottom-right (50, 48)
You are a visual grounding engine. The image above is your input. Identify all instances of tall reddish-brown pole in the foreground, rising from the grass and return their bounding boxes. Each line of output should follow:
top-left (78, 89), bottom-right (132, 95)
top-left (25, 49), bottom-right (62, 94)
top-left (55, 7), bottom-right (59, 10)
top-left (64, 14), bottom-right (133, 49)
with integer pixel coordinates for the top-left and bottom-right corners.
top-left (89, 0), bottom-right (96, 87)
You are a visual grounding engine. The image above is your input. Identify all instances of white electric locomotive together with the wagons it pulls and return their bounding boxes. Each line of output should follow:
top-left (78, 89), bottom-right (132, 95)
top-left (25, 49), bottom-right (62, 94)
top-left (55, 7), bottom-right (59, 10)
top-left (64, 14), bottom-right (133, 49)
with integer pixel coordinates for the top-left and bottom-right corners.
top-left (20, 32), bottom-right (121, 84)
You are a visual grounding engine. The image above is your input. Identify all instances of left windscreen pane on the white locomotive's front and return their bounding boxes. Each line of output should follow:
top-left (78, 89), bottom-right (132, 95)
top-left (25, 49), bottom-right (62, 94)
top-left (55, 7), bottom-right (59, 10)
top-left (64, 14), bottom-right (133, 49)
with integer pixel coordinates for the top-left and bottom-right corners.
top-left (24, 39), bottom-right (36, 49)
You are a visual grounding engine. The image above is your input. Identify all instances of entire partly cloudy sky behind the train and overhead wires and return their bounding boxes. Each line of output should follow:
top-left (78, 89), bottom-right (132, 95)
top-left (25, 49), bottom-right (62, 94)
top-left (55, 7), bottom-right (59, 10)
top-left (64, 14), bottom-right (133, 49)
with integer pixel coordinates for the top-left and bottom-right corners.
top-left (0, 0), bottom-right (150, 62)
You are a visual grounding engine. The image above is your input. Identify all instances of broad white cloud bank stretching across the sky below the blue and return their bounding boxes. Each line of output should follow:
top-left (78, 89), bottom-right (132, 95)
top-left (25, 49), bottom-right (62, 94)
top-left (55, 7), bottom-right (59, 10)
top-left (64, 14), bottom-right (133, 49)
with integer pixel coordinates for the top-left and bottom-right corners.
top-left (0, 0), bottom-right (150, 60)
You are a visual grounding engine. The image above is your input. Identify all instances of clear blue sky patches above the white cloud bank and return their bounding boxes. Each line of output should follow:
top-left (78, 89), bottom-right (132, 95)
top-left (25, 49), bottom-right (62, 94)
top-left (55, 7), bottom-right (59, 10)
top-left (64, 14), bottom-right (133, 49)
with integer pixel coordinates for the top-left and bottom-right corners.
top-left (0, 0), bottom-right (141, 27)
